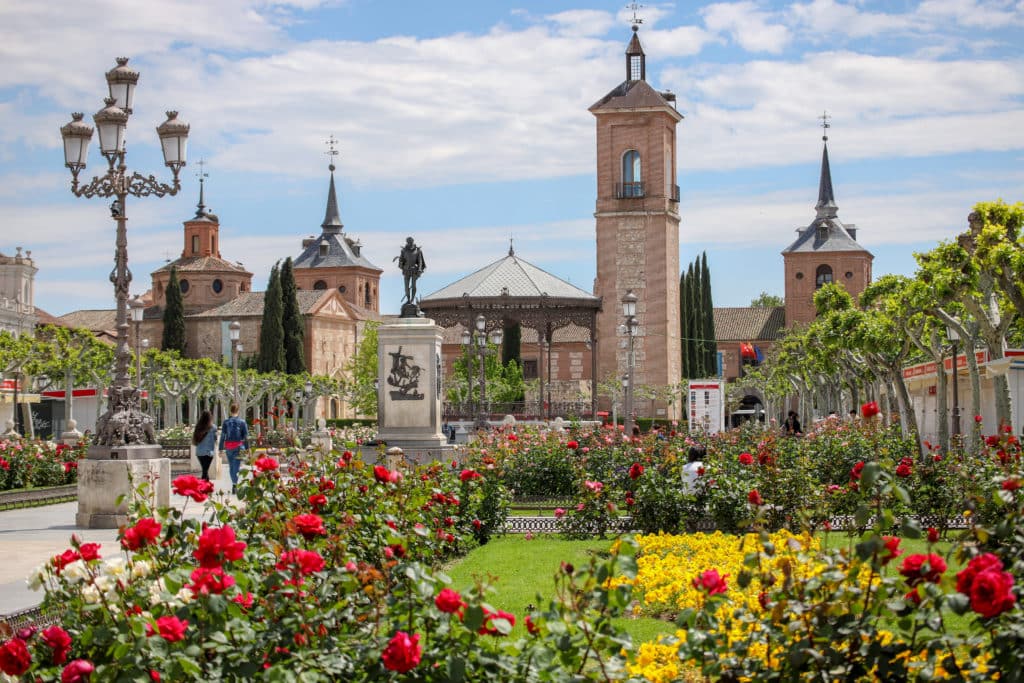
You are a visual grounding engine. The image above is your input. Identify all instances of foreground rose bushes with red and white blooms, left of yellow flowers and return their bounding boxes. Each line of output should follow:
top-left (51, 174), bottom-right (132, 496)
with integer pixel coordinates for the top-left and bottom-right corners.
top-left (6, 452), bottom-right (647, 682)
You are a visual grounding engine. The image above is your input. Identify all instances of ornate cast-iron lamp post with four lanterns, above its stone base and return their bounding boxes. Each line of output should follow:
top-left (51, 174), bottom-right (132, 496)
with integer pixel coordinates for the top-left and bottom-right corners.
top-left (60, 57), bottom-right (188, 449)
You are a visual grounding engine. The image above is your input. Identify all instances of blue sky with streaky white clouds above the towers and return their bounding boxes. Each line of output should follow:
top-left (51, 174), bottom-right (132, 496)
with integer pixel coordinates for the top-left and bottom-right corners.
top-left (0, 0), bottom-right (1024, 315)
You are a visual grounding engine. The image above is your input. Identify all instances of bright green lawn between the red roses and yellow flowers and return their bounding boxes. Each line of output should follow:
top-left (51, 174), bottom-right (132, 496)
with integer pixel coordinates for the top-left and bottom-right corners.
top-left (446, 535), bottom-right (675, 643)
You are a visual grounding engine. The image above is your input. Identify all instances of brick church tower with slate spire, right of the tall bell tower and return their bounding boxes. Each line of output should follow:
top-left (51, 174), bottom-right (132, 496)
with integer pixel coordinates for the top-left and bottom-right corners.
top-left (782, 120), bottom-right (874, 328)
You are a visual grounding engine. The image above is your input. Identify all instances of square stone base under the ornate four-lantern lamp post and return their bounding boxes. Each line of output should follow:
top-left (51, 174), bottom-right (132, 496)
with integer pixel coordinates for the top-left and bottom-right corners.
top-left (75, 456), bottom-right (171, 528)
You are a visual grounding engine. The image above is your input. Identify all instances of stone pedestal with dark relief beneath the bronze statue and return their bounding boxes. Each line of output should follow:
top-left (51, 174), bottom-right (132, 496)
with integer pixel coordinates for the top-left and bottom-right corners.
top-left (377, 317), bottom-right (450, 463)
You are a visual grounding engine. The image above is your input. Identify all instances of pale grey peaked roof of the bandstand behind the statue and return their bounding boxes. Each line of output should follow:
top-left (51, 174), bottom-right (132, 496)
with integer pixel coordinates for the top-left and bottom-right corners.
top-left (421, 250), bottom-right (600, 306)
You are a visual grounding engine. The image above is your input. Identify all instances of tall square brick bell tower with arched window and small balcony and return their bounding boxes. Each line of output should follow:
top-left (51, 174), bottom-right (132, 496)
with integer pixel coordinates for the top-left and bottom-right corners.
top-left (590, 23), bottom-right (683, 418)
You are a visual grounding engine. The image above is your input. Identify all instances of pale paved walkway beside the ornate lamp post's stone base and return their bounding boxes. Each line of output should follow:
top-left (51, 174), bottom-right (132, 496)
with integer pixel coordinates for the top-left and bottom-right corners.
top-left (0, 464), bottom-right (231, 614)
